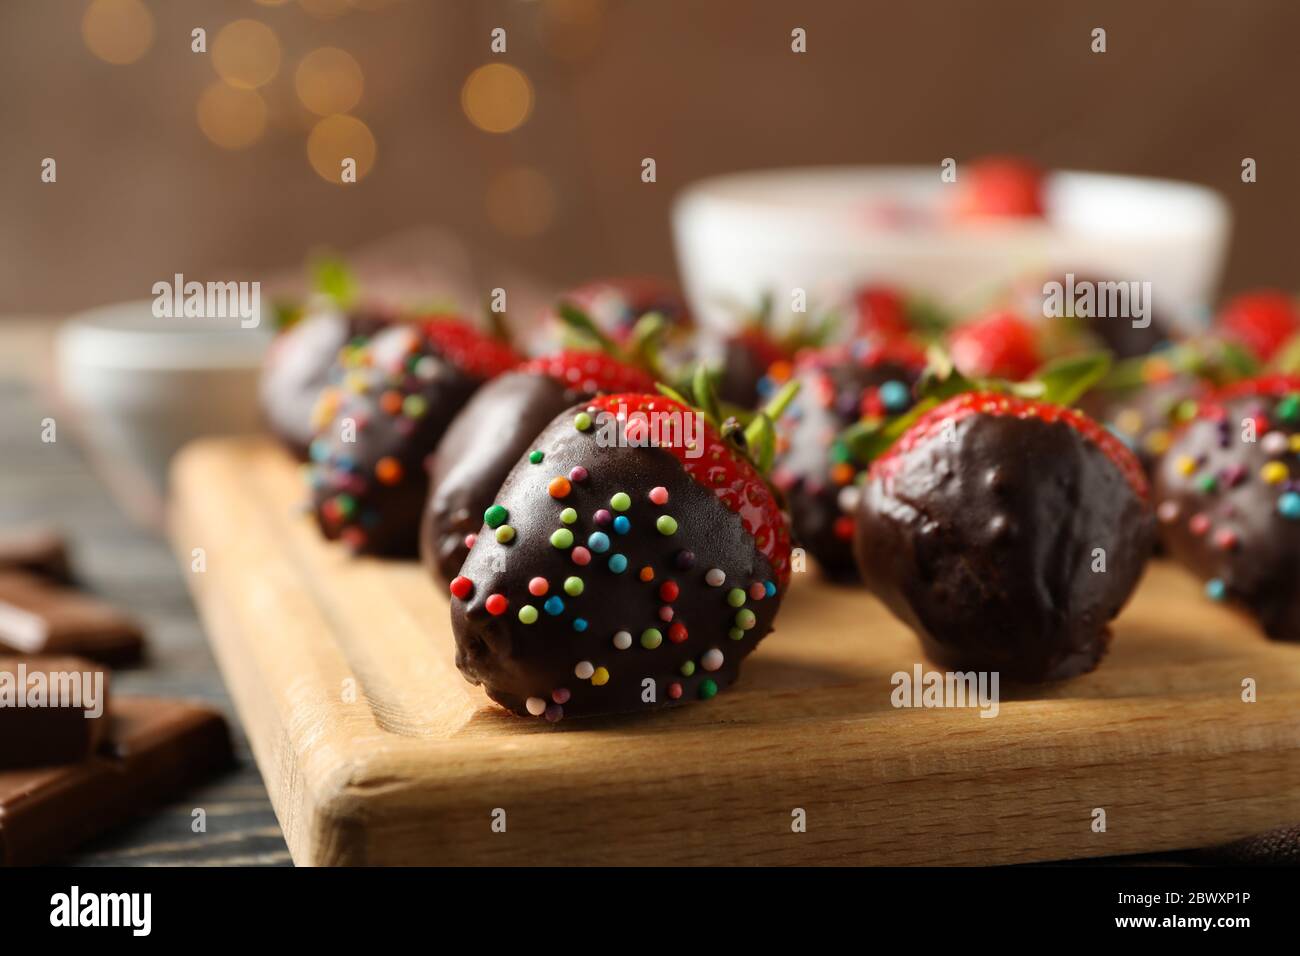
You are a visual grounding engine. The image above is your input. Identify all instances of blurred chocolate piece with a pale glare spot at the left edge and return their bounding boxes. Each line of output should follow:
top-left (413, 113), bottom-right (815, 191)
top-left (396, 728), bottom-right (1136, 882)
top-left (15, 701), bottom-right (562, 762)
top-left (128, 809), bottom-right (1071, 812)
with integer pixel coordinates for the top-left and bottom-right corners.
top-left (0, 571), bottom-right (144, 667)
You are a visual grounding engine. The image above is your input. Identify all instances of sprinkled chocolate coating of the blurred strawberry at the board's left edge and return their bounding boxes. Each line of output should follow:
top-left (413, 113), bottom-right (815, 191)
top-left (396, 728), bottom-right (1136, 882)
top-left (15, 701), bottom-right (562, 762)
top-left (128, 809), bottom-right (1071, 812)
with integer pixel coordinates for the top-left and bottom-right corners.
top-left (308, 325), bottom-right (482, 557)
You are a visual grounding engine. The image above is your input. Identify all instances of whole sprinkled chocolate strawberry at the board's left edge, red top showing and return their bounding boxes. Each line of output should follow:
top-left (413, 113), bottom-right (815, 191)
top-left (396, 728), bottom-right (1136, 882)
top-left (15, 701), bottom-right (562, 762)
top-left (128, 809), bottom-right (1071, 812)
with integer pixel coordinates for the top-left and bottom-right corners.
top-left (307, 316), bottom-right (519, 555)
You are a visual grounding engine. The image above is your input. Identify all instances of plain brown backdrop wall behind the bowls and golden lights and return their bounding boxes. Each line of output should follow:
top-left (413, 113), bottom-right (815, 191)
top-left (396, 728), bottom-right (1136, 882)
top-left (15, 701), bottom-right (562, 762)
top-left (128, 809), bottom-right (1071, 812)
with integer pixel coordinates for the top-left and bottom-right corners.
top-left (0, 0), bottom-right (1300, 313)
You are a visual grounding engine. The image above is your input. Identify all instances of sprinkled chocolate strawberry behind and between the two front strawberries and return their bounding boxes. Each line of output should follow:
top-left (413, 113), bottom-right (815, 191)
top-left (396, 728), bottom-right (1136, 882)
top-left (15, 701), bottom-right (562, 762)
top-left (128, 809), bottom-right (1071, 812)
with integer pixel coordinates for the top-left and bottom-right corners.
top-left (772, 339), bottom-right (926, 580)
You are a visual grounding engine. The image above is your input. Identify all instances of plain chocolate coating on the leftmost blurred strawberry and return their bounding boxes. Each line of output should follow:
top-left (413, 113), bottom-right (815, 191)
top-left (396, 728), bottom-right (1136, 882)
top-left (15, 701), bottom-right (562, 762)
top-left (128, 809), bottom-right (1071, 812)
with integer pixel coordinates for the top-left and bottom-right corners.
top-left (259, 306), bottom-right (393, 459)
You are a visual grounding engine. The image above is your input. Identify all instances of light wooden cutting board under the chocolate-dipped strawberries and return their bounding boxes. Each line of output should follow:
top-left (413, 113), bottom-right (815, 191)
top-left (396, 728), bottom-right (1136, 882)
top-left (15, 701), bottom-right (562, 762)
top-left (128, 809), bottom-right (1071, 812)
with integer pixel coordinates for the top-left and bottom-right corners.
top-left (172, 438), bottom-right (1300, 865)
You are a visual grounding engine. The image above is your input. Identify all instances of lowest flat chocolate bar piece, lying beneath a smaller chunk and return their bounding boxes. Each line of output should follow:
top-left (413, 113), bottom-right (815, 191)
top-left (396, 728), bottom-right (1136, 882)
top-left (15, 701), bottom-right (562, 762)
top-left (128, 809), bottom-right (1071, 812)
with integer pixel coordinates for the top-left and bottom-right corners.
top-left (0, 697), bottom-right (234, 866)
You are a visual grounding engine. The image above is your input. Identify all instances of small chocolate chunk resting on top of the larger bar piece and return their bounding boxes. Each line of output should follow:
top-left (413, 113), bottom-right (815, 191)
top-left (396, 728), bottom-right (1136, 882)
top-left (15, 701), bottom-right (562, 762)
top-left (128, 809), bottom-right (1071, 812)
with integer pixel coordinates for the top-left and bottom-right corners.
top-left (0, 657), bottom-right (108, 770)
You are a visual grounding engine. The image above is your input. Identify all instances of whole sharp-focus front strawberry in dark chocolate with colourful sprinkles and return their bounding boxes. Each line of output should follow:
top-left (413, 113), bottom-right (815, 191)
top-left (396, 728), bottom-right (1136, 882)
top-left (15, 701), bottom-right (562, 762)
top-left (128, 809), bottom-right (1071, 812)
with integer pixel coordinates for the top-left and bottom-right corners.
top-left (450, 392), bottom-right (790, 721)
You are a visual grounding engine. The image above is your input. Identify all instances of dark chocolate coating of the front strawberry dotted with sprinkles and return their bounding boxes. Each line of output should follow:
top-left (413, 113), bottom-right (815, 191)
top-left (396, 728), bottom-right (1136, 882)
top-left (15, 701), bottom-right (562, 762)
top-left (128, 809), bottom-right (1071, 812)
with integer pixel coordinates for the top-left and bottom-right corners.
top-left (451, 403), bottom-right (781, 721)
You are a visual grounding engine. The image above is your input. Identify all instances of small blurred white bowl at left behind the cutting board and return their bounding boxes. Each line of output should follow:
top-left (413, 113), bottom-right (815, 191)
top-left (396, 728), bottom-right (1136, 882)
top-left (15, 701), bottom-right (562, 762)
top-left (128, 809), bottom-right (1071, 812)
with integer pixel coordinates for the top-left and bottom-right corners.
top-left (56, 299), bottom-right (272, 489)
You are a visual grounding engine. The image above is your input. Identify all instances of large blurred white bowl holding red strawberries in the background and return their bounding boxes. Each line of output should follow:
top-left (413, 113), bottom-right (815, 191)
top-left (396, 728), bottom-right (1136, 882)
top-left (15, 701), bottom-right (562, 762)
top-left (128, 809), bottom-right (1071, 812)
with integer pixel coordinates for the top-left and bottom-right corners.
top-left (673, 166), bottom-right (1231, 335)
